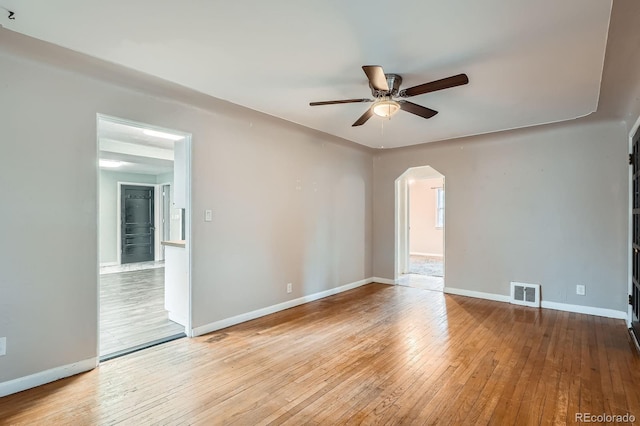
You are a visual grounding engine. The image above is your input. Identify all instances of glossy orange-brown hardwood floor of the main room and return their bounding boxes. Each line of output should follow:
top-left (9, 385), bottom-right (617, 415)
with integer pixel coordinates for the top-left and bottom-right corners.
top-left (0, 284), bottom-right (640, 425)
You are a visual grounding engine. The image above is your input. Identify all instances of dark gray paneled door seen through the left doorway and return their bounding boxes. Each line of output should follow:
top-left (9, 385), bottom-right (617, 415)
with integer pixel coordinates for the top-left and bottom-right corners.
top-left (120, 185), bottom-right (155, 263)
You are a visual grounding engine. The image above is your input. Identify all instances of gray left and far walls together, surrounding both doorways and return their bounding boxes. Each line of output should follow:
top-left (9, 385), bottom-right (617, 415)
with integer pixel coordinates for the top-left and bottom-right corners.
top-left (0, 24), bottom-right (628, 390)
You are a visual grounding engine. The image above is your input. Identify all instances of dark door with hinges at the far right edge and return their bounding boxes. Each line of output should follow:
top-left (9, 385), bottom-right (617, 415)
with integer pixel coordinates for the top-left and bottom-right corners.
top-left (630, 129), bottom-right (640, 341)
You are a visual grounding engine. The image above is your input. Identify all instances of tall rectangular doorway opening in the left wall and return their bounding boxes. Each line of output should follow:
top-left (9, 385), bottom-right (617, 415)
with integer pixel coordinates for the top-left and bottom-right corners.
top-left (97, 114), bottom-right (191, 361)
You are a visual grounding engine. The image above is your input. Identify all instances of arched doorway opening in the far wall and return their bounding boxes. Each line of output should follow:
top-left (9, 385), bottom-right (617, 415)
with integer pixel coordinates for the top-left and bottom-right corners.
top-left (395, 166), bottom-right (445, 291)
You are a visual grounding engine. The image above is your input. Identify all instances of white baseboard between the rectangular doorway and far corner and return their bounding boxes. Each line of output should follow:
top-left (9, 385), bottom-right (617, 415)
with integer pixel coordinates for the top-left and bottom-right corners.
top-left (192, 278), bottom-right (370, 337)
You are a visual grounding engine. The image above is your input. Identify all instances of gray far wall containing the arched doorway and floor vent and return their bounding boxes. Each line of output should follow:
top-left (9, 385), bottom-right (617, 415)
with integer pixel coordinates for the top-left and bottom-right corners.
top-left (373, 120), bottom-right (628, 312)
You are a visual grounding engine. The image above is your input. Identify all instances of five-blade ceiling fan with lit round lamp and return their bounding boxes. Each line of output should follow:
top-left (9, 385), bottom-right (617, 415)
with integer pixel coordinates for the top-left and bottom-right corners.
top-left (309, 65), bottom-right (469, 126)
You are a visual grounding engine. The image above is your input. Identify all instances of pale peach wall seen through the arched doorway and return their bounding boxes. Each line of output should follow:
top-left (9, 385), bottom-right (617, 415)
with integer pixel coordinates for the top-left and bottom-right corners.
top-left (409, 178), bottom-right (444, 256)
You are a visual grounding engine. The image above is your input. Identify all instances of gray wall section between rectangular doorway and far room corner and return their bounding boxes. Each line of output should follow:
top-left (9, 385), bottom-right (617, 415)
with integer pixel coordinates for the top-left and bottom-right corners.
top-left (193, 110), bottom-right (372, 327)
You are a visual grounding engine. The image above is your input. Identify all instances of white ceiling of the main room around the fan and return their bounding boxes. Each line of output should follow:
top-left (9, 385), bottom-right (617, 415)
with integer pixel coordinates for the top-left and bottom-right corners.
top-left (0, 0), bottom-right (612, 148)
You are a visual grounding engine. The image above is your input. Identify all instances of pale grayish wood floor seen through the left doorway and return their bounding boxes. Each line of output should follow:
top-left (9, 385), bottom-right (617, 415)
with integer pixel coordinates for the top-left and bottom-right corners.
top-left (100, 268), bottom-right (184, 356)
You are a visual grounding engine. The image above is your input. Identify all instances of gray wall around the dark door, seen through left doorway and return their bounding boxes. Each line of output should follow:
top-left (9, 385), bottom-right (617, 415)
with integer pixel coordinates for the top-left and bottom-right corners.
top-left (98, 170), bottom-right (161, 263)
